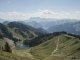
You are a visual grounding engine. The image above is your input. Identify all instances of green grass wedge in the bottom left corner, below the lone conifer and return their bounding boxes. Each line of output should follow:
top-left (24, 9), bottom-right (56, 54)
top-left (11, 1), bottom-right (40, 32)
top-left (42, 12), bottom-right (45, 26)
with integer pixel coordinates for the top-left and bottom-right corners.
top-left (0, 51), bottom-right (33, 60)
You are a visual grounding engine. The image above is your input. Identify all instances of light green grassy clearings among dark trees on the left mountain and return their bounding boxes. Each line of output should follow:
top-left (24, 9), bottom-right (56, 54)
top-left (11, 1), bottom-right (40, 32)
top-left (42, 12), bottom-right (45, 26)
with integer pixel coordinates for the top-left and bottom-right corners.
top-left (8, 27), bottom-right (37, 45)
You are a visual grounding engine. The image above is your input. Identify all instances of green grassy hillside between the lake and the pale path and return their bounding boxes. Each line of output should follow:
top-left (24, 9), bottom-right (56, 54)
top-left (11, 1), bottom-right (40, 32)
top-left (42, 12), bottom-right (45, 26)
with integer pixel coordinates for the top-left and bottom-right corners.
top-left (31, 37), bottom-right (57, 59)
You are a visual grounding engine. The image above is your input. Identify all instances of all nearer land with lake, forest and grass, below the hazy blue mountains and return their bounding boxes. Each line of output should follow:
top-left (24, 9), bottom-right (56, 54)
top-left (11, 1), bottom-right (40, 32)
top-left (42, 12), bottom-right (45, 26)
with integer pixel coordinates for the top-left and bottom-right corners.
top-left (0, 21), bottom-right (80, 60)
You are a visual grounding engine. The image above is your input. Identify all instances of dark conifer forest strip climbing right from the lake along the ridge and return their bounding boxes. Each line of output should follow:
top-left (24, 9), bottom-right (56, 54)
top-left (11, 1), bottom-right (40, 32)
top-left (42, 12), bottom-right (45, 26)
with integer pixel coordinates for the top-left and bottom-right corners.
top-left (26, 32), bottom-right (65, 47)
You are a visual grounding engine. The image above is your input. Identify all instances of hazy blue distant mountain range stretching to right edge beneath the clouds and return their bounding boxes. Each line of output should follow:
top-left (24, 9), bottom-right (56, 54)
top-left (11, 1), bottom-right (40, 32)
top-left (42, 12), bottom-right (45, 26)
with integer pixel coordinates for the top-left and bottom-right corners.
top-left (24, 18), bottom-right (80, 35)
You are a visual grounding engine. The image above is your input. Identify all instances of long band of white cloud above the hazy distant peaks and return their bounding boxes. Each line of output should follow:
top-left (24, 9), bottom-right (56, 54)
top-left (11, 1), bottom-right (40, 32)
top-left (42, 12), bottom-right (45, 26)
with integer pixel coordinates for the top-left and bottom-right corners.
top-left (0, 10), bottom-right (80, 20)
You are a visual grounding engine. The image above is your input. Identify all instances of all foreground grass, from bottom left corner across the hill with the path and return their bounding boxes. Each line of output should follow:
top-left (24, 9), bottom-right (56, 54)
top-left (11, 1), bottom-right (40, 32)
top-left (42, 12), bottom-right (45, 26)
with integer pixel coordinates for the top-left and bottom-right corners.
top-left (0, 34), bottom-right (80, 60)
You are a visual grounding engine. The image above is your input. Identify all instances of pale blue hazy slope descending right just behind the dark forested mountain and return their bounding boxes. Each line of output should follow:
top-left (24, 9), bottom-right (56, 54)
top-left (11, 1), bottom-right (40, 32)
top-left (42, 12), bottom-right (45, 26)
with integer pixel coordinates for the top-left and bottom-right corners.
top-left (18, 21), bottom-right (48, 34)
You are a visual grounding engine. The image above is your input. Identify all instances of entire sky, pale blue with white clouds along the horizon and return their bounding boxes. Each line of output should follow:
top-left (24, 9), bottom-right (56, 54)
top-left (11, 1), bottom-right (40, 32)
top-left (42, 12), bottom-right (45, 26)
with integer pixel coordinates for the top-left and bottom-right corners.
top-left (0, 0), bottom-right (80, 20)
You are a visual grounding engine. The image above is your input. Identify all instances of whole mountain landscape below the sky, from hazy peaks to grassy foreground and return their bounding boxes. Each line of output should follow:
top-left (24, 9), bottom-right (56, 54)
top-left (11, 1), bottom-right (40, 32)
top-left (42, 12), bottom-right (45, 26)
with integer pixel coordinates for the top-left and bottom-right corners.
top-left (0, 18), bottom-right (80, 60)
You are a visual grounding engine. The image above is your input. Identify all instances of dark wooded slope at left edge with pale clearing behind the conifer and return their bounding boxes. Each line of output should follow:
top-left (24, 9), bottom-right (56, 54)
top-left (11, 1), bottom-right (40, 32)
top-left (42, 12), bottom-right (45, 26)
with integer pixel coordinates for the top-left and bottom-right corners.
top-left (0, 23), bottom-right (17, 54)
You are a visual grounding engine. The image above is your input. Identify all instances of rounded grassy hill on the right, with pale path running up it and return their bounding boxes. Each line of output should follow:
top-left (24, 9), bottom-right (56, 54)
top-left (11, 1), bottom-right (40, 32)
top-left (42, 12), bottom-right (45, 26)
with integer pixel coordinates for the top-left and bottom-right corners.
top-left (31, 35), bottom-right (80, 60)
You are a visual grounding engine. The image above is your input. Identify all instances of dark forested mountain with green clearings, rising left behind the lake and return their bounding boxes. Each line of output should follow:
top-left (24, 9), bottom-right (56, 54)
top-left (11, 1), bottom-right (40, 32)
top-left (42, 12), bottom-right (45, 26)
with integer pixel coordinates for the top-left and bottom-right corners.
top-left (0, 21), bottom-right (46, 48)
